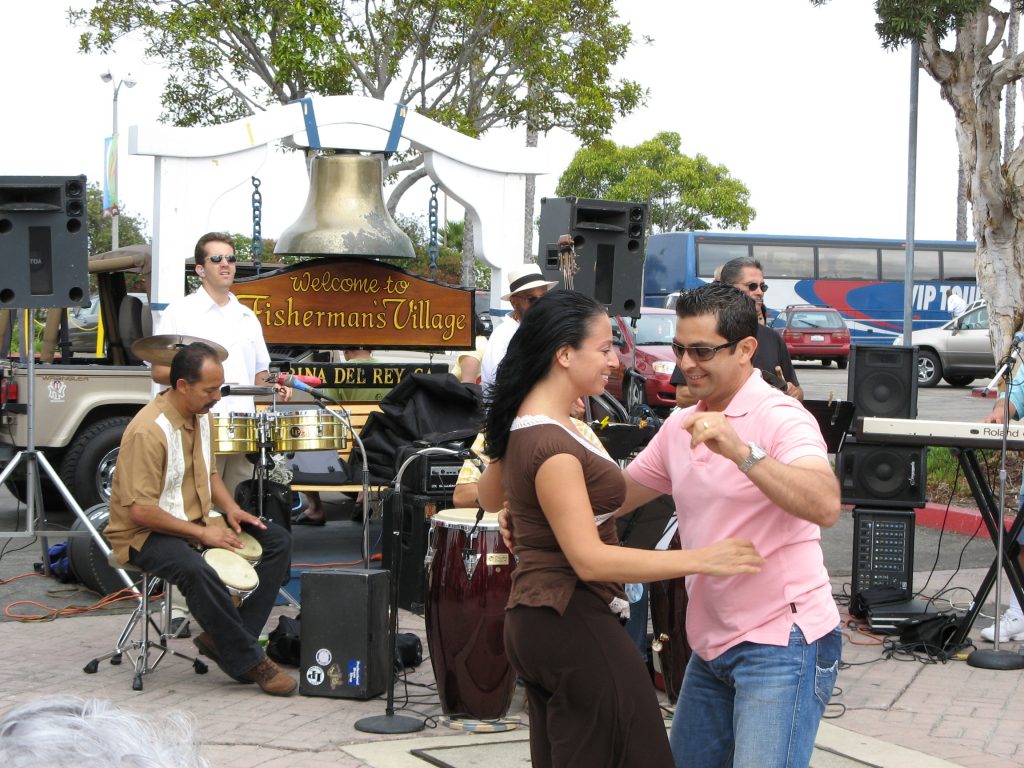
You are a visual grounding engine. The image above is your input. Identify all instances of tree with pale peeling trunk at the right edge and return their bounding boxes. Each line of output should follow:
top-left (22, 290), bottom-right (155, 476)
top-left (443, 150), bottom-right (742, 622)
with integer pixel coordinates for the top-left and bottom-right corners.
top-left (811, 0), bottom-right (1024, 357)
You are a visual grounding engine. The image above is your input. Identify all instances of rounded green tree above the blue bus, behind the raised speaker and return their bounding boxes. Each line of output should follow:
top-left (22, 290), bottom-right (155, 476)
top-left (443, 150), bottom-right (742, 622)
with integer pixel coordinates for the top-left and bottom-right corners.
top-left (556, 132), bottom-right (756, 231)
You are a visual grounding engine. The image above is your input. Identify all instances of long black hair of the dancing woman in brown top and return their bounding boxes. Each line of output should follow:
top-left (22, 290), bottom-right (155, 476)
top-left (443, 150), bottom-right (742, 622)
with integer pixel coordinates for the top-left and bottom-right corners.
top-left (484, 290), bottom-right (606, 459)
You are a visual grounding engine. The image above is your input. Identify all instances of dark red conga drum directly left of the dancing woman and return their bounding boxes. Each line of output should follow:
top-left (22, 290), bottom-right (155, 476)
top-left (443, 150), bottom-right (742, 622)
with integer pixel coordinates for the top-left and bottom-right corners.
top-left (424, 509), bottom-right (516, 720)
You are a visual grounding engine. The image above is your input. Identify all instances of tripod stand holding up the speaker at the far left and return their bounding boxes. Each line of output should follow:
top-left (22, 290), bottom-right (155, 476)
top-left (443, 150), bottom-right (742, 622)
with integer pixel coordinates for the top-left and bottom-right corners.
top-left (0, 309), bottom-right (141, 601)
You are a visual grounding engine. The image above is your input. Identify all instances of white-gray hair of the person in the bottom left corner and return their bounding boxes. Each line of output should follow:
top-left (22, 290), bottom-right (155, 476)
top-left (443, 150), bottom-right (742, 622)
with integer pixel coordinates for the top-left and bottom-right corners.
top-left (0, 696), bottom-right (210, 768)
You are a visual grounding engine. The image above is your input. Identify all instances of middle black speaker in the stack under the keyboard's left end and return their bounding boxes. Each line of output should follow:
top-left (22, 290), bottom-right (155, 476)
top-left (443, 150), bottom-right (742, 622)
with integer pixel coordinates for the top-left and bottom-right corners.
top-left (836, 438), bottom-right (928, 508)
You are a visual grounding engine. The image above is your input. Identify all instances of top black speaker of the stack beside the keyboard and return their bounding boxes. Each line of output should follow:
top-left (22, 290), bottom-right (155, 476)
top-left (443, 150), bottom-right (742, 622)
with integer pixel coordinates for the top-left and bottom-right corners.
top-left (846, 344), bottom-right (918, 419)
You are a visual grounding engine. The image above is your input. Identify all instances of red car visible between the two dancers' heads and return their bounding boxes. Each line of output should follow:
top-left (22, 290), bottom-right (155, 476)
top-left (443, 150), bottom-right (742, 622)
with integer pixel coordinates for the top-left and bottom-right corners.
top-left (608, 306), bottom-right (676, 416)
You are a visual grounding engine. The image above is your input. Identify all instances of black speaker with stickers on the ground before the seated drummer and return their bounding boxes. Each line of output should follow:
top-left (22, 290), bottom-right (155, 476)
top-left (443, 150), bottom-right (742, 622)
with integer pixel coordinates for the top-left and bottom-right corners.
top-left (299, 569), bottom-right (394, 699)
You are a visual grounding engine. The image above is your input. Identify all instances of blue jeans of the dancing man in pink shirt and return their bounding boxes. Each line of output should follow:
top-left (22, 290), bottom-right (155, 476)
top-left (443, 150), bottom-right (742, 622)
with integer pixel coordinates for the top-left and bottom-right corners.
top-left (670, 625), bottom-right (843, 768)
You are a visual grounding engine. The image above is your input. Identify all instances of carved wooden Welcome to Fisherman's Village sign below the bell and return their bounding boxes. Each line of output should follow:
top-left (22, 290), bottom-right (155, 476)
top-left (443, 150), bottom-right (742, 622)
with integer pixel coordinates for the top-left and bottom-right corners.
top-left (231, 258), bottom-right (474, 350)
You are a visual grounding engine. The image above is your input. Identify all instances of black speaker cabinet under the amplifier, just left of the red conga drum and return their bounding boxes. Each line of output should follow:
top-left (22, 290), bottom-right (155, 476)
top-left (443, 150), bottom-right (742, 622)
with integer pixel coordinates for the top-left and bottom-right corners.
top-left (381, 494), bottom-right (455, 615)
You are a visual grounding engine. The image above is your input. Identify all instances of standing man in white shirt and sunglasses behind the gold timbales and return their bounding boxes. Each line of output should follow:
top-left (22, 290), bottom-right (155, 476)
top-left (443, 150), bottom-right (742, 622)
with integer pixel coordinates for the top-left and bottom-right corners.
top-left (153, 232), bottom-right (292, 497)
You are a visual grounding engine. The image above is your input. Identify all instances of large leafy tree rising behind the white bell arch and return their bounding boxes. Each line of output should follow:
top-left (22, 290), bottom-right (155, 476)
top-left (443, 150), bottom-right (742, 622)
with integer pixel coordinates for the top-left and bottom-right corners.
top-left (69, 0), bottom-right (644, 204)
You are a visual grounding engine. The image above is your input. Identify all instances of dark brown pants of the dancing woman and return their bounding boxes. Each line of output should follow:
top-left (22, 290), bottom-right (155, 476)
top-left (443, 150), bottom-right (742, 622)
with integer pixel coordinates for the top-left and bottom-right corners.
top-left (505, 587), bottom-right (675, 768)
